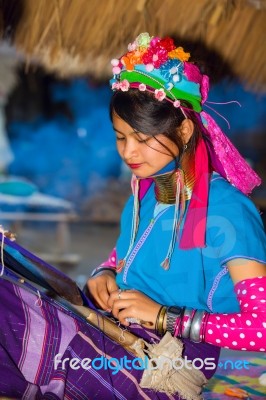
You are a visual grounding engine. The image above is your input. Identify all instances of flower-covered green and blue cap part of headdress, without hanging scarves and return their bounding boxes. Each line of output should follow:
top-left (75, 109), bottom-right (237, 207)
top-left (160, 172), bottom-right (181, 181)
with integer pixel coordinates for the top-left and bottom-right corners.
top-left (110, 33), bottom-right (205, 112)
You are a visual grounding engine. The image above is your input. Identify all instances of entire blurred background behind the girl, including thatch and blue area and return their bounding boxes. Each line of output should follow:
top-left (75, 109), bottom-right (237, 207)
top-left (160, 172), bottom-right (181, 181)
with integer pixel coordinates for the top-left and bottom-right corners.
top-left (0, 0), bottom-right (266, 285)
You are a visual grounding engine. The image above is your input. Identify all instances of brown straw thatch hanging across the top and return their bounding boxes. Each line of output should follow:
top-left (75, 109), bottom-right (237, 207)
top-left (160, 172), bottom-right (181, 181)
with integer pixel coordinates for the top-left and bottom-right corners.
top-left (0, 0), bottom-right (266, 89)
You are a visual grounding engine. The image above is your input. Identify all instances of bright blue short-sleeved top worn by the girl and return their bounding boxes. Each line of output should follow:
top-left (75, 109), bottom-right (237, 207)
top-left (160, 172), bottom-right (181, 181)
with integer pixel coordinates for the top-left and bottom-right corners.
top-left (116, 173), bottom-right (266, 313)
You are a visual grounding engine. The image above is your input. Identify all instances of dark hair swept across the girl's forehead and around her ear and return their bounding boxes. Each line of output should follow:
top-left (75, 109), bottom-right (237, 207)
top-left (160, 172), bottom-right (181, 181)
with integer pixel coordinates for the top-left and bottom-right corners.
top-left (110, 89), bottom-right (203, 157)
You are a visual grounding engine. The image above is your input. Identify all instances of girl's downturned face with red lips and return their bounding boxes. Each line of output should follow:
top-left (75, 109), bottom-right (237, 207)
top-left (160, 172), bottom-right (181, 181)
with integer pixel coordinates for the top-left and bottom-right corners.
top-left (113, 114), bottom-right (179, 178)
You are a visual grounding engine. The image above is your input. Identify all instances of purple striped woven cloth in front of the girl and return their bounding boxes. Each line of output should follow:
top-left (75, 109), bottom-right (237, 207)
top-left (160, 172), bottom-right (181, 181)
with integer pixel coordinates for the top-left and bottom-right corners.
top-left (0, 250), bottom-right (219, 400)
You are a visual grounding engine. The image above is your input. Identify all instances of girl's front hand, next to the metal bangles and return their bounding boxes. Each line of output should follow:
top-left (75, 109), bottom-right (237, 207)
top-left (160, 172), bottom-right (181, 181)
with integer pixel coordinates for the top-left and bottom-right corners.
top-left (108, 289), bottom-right (161, 329)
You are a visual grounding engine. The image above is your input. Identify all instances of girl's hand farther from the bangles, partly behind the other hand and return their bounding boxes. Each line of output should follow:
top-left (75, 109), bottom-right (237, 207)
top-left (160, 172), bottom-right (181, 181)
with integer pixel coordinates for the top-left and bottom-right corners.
top-left (87, 270), bottom-right (118, 311)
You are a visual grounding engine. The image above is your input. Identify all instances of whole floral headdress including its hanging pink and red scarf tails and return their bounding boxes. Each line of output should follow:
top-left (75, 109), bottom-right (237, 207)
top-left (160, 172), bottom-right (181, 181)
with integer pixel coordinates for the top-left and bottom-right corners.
top-left (110, 33), bottom-right (261, 256)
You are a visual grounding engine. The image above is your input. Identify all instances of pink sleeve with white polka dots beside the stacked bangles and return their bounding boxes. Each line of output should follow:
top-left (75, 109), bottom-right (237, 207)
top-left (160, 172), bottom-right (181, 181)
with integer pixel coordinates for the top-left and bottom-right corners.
top-left (201, 277), bottom-right (266, 351)
